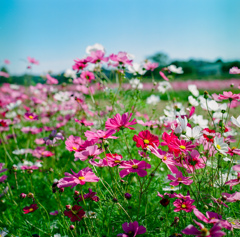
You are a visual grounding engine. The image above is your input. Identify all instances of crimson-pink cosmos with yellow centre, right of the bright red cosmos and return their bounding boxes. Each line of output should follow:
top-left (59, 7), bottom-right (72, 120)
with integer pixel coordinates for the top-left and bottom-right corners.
top-left (168, 139), bottom-right (196, 156)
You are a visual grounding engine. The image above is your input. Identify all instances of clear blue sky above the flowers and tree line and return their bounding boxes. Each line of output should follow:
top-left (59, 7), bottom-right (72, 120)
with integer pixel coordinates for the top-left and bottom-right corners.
top-left (0, 0), bottom-right (240, 74)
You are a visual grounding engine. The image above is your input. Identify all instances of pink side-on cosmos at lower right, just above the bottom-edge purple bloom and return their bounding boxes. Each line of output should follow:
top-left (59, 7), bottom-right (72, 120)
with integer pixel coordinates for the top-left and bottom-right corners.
top-left (193, 208), bottom-right (233, 230)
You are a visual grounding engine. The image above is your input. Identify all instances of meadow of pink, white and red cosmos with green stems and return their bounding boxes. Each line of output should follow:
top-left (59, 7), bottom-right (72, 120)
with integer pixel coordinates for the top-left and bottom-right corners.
top-left (0, 44), bottom-right (240, 237)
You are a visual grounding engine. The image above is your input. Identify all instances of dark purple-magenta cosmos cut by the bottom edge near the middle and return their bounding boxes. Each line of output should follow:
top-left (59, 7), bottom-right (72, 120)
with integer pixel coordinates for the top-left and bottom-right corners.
top-left (117, 221), bottom-right (146, 237)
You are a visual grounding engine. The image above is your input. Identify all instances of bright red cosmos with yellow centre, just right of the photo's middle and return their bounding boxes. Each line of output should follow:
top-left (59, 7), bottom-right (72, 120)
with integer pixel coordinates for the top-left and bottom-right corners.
top-left (133, 130), bottom-right (159, 149)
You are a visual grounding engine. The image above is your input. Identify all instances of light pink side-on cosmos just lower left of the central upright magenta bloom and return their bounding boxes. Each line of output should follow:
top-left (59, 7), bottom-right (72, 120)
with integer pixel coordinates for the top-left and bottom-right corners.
top-left (84, 129), bottom-right (118, 142)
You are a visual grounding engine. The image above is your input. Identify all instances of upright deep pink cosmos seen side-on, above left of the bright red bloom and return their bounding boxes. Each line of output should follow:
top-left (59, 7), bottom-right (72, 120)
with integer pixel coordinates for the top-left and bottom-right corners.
top-left (105, 112), bottom-right (137, 131)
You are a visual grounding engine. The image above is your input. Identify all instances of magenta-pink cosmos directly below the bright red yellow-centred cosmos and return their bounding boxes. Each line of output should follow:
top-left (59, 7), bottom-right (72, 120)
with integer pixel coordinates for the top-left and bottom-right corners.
top-left (119, 159), bottom-right (151, 178)
